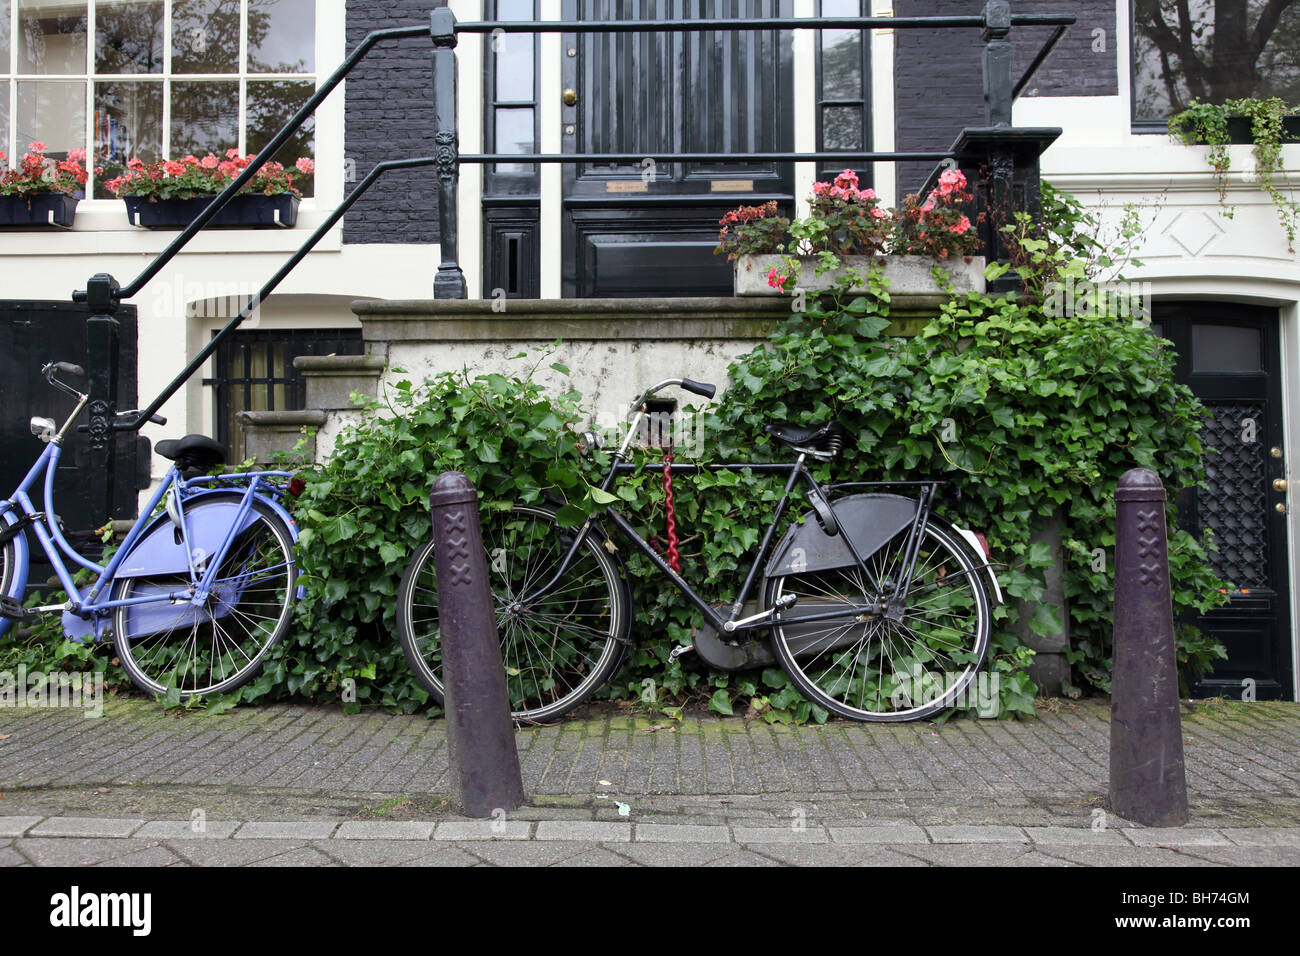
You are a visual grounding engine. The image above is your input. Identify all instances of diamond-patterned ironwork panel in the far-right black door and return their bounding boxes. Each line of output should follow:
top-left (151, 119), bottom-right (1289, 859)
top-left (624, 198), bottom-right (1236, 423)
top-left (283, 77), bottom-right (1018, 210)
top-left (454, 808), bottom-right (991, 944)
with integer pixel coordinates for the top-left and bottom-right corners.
top-left (1197, 402), bottom-right (1270, 589)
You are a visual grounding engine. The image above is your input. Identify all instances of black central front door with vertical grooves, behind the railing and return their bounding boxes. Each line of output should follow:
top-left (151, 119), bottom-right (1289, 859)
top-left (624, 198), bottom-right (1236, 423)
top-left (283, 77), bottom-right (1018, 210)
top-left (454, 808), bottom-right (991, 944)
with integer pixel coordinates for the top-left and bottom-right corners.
top-left (562, 0), bottom-right (793, 297)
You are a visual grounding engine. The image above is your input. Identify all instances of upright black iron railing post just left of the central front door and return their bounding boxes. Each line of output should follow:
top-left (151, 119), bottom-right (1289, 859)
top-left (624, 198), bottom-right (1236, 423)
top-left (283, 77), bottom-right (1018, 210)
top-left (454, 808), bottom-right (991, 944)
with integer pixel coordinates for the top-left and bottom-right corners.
top-left (429, 7), bottom-right (468, 299)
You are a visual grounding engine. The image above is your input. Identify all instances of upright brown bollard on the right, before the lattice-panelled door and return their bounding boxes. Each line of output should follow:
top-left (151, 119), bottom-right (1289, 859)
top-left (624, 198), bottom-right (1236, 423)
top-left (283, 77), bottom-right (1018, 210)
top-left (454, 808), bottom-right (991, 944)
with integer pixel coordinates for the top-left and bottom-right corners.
top-left (1110, 468), bottom-right (1187, 826)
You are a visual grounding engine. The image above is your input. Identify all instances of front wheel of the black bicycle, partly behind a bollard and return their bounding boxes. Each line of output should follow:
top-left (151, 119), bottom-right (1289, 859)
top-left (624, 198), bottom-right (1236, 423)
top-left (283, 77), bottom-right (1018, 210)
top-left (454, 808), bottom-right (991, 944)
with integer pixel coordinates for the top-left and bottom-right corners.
top-left (398, 505), bottom-right (632, 722)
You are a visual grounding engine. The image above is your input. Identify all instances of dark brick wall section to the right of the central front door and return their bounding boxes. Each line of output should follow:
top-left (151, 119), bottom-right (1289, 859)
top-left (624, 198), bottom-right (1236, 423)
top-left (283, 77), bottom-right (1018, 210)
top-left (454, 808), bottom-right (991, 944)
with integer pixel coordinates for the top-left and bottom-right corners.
top-left (894, 0), bottom-right (1118, 195)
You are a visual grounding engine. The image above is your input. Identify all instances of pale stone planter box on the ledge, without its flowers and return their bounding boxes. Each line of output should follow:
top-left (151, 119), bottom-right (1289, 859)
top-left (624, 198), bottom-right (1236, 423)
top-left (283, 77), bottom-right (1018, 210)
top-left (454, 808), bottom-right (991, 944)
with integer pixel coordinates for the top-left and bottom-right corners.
top-left (736, 255), bottom-right (985, 306)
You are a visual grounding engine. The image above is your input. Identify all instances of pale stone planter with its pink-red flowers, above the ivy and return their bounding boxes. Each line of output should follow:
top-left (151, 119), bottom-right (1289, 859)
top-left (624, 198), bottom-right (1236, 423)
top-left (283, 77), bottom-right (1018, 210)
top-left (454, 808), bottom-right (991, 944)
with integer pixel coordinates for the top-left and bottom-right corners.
top-left (715, 169), bottom-right (984, 304)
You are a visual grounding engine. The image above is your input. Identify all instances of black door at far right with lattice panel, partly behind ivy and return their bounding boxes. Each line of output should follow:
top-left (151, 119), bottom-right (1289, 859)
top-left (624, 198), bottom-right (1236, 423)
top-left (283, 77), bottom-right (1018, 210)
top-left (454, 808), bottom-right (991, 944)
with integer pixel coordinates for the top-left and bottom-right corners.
top-left (1153, 302), bottom-right (1295, 700)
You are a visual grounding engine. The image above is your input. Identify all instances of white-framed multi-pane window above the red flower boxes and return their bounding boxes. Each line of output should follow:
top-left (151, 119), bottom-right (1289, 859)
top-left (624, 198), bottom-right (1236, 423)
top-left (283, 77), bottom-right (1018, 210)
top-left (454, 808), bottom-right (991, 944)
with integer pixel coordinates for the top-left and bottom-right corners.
top-left (0, 0), bottom-right (316, 198)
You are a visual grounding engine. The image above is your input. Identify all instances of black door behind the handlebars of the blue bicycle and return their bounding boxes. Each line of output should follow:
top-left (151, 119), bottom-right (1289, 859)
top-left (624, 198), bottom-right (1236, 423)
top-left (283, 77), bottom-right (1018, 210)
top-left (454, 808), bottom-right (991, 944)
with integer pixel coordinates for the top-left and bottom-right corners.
top-left (0, 300), bottom-right (150, 561)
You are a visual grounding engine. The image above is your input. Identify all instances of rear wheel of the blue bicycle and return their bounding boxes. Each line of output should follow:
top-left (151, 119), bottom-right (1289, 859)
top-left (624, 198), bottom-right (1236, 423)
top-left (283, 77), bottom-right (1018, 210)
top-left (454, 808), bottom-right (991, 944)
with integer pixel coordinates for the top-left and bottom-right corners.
top-left (113, 494), bottom-right (298, 700)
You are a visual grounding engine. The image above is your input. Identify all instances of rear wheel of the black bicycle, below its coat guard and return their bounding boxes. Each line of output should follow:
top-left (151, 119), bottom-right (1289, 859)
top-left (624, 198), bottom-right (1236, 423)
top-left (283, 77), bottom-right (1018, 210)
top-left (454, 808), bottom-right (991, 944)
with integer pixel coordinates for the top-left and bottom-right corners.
top-left (767, 515), bottom-right (996, 721)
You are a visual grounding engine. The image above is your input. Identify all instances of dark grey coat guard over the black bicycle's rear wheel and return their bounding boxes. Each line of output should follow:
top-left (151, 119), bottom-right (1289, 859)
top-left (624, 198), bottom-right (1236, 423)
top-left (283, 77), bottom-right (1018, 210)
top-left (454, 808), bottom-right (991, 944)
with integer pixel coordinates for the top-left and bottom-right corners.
top-left (763, 493), bottom-right (917, 578)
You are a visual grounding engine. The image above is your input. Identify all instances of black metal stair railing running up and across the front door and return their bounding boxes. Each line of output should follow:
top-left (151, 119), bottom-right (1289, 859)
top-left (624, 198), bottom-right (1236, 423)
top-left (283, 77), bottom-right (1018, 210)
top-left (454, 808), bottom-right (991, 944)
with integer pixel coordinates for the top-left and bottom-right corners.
top-left (65, 0), bottom-right (1075, 514)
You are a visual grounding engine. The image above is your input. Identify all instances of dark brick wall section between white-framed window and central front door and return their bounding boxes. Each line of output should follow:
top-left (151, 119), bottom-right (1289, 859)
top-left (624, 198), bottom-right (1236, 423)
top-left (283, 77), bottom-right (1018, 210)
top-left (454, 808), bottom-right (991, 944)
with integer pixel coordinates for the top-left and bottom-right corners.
top-left (343, 0), bottom-right (446, 243)
